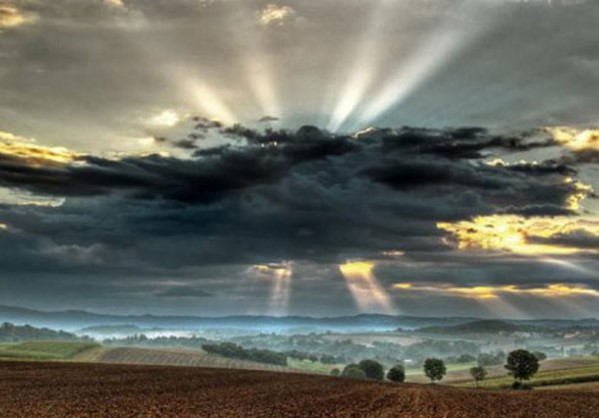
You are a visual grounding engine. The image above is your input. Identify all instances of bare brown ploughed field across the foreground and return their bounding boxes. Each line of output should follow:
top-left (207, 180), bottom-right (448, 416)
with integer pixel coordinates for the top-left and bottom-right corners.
top-left (0, 362), bottom-right (599, 418)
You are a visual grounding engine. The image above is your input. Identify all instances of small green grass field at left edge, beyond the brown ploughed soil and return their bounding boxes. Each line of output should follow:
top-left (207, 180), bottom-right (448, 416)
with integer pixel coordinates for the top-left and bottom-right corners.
top-left (0, 341), bottom-right (99, 360)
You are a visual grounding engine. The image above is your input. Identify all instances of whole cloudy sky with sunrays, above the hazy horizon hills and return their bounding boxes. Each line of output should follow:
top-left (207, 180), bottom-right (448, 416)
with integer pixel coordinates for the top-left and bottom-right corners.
top-left (0, 0), bottom-right (599, 318)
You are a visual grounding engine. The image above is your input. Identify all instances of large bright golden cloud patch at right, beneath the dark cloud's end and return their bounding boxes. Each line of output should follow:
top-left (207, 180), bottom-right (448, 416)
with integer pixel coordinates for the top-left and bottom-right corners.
top-left (437, 215), bottom-right (599, 255)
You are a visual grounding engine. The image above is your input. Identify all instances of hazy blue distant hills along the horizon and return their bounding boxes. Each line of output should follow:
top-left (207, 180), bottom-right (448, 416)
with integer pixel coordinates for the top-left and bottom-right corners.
top-left (0, 306), bottom-right (599, 332)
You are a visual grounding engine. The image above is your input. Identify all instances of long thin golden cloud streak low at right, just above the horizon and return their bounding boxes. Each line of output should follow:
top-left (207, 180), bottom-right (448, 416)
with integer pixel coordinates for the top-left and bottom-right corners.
top-left (393, 283), bottom-right (599, 300)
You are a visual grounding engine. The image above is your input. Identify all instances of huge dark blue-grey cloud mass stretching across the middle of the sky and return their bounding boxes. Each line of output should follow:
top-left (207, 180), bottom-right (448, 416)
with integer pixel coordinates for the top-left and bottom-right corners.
top-left (0, 126), bottom-right (588, 271)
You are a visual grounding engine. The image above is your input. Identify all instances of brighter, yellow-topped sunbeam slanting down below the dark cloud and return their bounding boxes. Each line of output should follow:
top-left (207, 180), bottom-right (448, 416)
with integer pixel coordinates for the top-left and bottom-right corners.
top-left (339, 261), bottom-right (395, 314)
